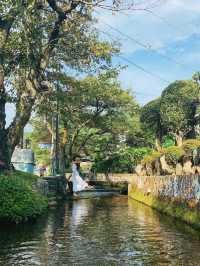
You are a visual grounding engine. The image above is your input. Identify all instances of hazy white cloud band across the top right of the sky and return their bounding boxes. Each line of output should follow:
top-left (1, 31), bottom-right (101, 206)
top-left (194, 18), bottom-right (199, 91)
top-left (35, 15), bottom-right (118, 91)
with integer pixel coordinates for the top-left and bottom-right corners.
top-left (97, 0), bottom-right (200, 53)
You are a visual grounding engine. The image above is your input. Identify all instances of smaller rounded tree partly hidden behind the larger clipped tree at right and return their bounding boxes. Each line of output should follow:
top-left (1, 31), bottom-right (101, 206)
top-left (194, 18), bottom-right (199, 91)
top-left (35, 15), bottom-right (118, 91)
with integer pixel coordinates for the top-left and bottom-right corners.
top-left (140, 98), bottom-right (162, 150)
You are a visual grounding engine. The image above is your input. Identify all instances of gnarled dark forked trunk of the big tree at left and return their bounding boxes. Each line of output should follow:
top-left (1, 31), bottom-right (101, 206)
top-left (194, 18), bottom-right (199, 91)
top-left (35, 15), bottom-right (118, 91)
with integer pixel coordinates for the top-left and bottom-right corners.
top-left (0, 0), bottom-right (79, 169)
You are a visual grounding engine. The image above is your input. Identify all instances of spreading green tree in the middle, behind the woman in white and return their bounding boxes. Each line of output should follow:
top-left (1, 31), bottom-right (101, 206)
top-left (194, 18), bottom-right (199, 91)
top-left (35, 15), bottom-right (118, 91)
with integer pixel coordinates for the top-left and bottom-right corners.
top-left (34, 70), bottom-right (139, 171)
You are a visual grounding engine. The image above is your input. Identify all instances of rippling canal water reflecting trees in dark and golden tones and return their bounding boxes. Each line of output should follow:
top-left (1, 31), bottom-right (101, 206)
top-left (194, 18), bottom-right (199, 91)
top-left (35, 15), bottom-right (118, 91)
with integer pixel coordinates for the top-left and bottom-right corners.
top-left (0, 197), bottom-right (200, 266)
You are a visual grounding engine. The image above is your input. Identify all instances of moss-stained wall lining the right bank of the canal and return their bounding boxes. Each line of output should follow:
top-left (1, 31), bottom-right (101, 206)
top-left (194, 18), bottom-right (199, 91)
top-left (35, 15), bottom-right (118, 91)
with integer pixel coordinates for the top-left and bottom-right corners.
top-left (128, 175), bottom-right (200, 228)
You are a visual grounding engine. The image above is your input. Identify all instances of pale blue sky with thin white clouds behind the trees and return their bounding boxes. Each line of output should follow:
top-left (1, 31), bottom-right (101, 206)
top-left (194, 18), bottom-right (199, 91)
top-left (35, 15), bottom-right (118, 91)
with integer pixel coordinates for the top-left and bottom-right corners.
top-left (6, 0), bottom-right (200, 127)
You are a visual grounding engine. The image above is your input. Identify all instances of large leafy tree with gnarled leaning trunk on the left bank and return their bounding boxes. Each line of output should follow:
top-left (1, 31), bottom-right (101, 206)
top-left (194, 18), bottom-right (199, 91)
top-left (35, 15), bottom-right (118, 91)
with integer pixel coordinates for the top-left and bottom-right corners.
top-left (0, 0), bottom-right (119, 168)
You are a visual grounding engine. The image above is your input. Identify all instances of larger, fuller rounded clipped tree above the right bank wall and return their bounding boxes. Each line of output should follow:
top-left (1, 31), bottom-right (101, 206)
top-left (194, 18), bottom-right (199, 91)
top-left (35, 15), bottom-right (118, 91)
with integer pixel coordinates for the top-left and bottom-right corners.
top-left (160, 81), bottom-right (199, 146)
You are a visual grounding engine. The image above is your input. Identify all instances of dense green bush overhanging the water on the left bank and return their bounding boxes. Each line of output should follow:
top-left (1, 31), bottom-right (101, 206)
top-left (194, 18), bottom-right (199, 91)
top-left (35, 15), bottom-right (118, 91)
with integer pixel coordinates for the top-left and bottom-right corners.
top-left (0, 172), bottom-right (48, 223)
